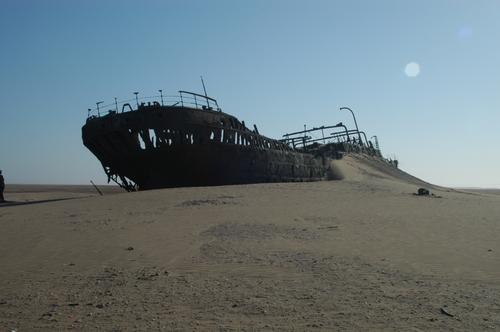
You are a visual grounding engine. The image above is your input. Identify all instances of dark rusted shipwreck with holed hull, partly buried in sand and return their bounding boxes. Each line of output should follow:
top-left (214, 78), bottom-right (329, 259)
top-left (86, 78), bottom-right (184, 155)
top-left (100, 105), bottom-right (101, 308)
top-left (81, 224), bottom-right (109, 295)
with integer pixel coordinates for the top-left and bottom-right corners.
top-left (82, 91), bottom-right (378, 191)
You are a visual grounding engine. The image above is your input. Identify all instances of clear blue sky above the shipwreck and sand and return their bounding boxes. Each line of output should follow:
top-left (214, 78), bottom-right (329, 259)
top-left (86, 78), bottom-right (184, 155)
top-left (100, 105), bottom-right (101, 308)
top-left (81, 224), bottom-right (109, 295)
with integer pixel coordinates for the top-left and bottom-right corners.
top-left (0, 0), bottom-right (500, 187)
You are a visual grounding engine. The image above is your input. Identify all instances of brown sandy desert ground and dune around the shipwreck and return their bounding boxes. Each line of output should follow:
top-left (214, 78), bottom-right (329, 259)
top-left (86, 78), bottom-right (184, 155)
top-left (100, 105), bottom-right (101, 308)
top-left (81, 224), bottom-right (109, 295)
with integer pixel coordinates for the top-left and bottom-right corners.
top-left (0, 156), bottom-right (500, 331)
